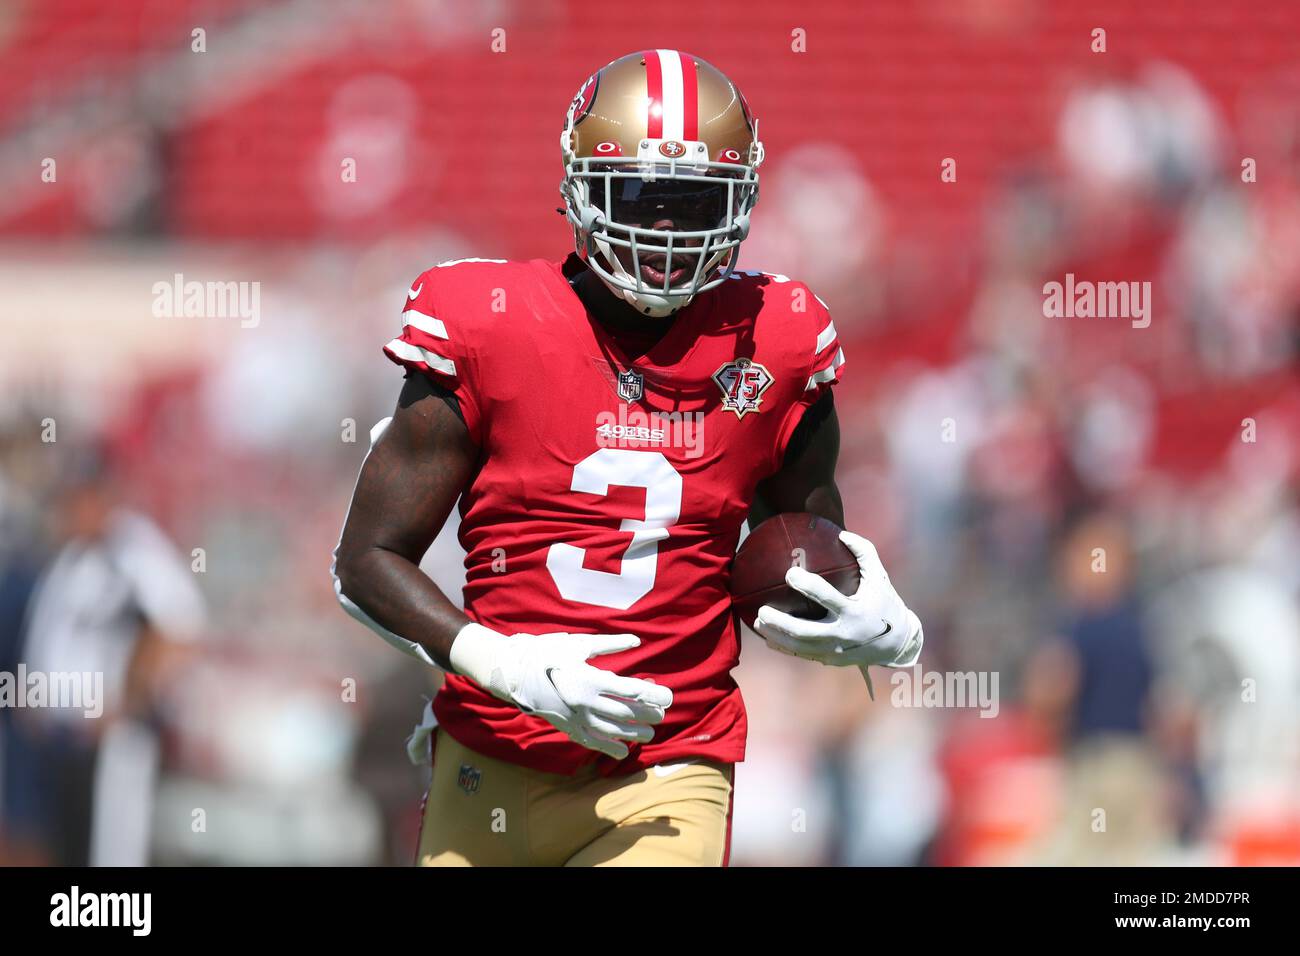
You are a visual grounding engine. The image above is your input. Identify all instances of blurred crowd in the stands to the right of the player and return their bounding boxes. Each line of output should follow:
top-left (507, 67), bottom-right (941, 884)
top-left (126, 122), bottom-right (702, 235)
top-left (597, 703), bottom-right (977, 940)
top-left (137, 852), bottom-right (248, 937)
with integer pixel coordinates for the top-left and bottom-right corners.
top-left (737, 57), bottom-right (1300, 865)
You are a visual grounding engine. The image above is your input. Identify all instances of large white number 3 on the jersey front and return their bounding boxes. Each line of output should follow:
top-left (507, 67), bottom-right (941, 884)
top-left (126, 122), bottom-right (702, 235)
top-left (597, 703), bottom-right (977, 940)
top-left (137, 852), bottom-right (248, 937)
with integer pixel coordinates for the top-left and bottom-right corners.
top-left (546, 449), bottom-right (681, 611)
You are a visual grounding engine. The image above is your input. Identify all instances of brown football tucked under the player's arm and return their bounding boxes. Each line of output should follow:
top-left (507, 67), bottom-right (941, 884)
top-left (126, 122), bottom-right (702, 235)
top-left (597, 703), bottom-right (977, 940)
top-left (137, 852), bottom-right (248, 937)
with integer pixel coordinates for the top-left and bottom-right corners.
top-left (731, 512), bottom-right (859, 627)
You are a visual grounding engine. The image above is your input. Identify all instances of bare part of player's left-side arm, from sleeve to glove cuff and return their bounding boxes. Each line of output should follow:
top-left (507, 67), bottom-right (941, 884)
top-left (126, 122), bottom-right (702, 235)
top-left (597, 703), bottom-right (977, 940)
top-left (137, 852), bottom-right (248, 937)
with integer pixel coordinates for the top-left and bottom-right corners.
top-left (334, 375), bottom-right (478, 670)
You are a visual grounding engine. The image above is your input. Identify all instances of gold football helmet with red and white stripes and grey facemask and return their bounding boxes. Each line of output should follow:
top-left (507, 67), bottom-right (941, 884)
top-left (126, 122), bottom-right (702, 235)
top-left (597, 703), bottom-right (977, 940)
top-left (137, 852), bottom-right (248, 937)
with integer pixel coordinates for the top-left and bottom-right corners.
top-left (560, 49), bottom-right (763, 316)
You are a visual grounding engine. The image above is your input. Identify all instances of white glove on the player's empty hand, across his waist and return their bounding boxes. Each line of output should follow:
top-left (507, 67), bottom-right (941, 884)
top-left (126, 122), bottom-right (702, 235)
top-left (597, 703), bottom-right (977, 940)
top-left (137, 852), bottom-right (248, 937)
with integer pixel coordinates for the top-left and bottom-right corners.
top-left (451, 623), bottom-right (672, 760)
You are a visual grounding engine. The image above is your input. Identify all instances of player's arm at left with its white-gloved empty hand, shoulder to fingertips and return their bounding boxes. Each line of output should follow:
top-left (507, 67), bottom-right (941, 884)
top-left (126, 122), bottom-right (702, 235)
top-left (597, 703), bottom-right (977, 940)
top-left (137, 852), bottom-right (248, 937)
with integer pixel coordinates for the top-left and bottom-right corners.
top-left (334, 375), bottom-right (672, 760)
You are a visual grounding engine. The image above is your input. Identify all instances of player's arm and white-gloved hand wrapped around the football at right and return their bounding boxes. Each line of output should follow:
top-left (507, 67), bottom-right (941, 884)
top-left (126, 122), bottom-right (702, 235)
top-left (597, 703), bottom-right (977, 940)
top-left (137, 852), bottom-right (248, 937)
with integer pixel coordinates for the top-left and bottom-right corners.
top-left (750, 389), bottom-right (924, 688)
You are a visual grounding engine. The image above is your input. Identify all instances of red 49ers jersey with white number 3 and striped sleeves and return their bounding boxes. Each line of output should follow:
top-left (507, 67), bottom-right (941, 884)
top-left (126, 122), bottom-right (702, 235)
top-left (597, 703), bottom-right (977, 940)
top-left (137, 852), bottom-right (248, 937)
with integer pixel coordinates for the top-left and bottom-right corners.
top-left (384, 256), bottom-right (844, 774)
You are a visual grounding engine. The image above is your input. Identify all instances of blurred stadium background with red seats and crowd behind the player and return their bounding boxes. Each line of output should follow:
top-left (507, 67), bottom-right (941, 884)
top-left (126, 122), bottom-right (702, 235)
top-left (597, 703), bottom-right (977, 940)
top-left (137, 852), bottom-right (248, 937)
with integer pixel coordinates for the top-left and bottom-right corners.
top-left (0, 0), bottom-right (1300, 865)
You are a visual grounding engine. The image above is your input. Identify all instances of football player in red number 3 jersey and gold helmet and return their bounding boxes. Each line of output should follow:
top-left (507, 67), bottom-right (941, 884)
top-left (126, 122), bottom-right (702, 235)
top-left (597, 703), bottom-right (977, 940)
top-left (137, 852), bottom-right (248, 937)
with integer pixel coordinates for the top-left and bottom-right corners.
top-left (334, 49), bottom-right (922, 866)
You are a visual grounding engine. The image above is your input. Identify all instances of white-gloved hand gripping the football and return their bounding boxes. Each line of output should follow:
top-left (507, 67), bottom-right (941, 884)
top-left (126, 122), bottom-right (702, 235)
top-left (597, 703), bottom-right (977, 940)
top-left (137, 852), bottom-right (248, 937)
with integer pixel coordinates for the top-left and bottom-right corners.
top-left (754, 531), bottom-right (924, 672)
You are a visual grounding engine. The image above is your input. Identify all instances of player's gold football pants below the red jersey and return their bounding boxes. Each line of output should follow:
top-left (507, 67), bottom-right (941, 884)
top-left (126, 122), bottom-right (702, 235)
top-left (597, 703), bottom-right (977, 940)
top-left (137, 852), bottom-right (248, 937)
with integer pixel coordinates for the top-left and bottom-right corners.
top-left (416, 727), bottom-right (735, 866)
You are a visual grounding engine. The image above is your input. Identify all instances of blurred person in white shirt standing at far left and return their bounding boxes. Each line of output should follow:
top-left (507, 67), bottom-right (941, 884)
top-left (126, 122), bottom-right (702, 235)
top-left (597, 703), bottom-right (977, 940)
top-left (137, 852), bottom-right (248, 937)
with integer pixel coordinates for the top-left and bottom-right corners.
top-left (9, 445), bottom-right (204, 865)
